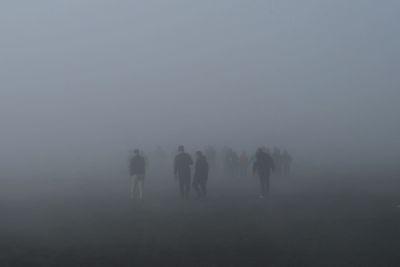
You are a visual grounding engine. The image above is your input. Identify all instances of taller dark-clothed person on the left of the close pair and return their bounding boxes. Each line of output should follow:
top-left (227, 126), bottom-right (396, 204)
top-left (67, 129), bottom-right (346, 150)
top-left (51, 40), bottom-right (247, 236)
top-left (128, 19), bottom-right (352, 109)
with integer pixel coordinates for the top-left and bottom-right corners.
top-left (174, 146), bottom-right (193, 199)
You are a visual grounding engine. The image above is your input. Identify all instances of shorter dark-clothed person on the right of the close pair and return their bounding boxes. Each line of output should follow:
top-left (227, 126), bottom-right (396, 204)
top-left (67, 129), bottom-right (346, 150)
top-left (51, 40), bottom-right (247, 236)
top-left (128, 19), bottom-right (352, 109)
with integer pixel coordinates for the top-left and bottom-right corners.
top-left (193, 151), bottom-right (208, 198)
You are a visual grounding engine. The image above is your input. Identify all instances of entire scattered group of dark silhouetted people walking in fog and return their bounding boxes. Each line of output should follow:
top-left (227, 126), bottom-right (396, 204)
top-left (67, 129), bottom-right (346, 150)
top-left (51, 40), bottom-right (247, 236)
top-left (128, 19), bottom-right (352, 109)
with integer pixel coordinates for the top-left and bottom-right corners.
top-left (130, 145), bottom-right (292, 200)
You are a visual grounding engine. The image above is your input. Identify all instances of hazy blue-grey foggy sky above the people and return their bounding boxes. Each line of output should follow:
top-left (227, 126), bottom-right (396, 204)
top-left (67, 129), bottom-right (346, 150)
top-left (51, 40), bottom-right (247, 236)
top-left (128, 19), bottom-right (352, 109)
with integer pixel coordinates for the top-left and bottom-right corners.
top-left (0, 0), bottom-right (400, 174)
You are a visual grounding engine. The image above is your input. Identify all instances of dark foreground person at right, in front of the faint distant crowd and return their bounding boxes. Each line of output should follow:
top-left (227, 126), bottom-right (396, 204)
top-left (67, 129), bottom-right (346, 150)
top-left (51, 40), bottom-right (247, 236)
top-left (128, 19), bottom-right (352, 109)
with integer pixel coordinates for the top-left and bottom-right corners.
top-left (253, 148), bottom-right (275, 198)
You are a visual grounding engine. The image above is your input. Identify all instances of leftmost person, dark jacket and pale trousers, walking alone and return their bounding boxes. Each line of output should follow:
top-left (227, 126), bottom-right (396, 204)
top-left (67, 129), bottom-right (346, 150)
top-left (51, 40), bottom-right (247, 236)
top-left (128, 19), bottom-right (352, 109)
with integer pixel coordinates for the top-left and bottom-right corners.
top-left (130, 149), bottom-right (146, 200)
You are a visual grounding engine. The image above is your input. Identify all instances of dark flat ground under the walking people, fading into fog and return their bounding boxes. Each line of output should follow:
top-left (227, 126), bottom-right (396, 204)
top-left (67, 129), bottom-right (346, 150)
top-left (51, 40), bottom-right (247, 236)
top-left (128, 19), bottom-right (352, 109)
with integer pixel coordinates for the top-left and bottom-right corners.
top-left (0, 171), bottom-right (400, 267)
